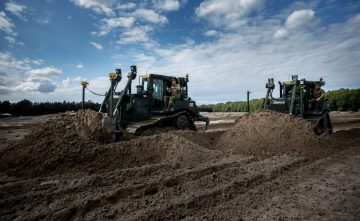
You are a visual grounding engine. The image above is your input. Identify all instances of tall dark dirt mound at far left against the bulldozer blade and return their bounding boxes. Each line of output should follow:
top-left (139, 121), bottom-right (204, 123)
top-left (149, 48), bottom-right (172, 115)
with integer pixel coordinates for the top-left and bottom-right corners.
top-left (0, 110), bottom-right (102, 175)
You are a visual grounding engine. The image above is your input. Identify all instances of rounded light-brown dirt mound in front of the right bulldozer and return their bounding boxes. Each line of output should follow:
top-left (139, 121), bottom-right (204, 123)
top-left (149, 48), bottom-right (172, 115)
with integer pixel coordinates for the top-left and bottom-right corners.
top-left (214, 111), bottom-right (321, 156)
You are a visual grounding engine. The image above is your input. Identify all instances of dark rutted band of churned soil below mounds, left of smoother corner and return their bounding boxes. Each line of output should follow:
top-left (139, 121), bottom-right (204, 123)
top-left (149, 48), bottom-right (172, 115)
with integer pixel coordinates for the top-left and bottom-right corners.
top-left (0, 155), bottom-right (303, 220)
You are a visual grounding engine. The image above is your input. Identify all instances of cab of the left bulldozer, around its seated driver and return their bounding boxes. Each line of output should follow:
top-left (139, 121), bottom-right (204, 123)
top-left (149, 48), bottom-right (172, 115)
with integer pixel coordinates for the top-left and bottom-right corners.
top-left (140, 74), bottom-right (188, 111)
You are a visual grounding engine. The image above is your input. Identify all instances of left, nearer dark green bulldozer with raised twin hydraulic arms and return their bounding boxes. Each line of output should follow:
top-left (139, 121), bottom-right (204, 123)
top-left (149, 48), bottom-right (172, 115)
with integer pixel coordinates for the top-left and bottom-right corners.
top-left (99, 65), bottom-right (209, 140)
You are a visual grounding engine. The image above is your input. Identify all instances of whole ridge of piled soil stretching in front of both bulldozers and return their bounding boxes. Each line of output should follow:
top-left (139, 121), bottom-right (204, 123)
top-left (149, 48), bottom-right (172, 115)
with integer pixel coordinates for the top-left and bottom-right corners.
top-left (0, 110), bottom-right (346, 176)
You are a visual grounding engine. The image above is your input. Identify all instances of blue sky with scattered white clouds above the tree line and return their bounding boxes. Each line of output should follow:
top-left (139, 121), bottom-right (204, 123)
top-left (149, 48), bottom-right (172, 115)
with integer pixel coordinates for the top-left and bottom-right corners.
top-left (0, 0), bottom-right (360, 104)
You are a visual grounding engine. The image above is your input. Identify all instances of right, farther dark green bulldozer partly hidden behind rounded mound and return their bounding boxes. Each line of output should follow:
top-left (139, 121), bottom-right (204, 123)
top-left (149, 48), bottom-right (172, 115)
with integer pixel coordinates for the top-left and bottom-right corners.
top-left (263, 75), bottom-right (332, 136)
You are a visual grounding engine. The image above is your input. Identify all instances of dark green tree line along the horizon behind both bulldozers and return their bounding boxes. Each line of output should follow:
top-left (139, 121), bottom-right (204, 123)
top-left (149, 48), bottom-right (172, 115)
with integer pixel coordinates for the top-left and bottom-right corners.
top-left (0, 89), bottom-right (360, 116)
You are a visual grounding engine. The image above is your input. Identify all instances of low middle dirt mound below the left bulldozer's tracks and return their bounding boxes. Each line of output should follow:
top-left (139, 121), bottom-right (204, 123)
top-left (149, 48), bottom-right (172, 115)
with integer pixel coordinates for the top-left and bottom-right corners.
top-left (107, 132), bottom-right (220, 167)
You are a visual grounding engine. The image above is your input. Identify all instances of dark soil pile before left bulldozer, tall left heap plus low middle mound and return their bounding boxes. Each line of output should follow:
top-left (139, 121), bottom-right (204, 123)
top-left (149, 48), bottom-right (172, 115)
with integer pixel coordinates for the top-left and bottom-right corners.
top-left (0, 110), bottom-right (219, 176)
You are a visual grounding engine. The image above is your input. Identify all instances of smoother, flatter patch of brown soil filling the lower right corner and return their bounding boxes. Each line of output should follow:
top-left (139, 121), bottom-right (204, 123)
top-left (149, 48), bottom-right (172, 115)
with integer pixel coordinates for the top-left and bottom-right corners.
top-left (195, 146), bottom-right (360, 221)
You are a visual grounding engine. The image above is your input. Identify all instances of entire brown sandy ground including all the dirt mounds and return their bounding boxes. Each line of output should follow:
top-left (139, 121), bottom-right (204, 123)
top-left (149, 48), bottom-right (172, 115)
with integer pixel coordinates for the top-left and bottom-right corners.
top-left (0, 111), bottom-right (360, 220)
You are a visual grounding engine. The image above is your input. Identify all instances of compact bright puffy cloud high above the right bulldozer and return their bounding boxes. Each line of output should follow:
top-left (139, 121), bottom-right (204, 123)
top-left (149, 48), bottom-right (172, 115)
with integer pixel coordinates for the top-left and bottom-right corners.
top-left (285, 9), bottom-right (315, 29)
